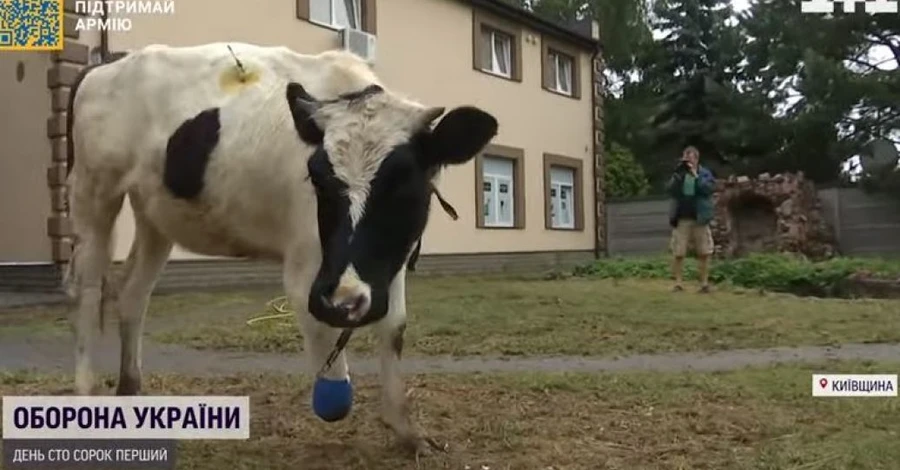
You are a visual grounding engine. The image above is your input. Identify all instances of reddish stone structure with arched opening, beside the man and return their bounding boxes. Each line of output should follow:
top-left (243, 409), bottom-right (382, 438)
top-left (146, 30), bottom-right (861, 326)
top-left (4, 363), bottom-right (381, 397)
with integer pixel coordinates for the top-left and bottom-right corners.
top-left (711, 172), bottom-right (836, 259)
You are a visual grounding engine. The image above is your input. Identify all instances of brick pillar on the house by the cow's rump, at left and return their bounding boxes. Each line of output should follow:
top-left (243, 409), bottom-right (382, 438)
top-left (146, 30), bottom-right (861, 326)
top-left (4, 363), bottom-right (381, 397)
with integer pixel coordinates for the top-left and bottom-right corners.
top-left (47, 0), bottom-right (90, 264)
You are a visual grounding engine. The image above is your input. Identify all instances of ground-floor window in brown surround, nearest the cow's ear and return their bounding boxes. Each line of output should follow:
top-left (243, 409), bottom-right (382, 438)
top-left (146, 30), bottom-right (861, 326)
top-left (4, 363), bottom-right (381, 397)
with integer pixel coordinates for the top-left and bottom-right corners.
top-left (475, 144), bottom-right (525, 228)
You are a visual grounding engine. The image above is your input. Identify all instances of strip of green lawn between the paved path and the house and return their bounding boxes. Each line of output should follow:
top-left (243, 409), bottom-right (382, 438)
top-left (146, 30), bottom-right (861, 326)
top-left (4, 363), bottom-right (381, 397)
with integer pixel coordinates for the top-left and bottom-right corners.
top-left (0, 277), bottom-right (900, 355)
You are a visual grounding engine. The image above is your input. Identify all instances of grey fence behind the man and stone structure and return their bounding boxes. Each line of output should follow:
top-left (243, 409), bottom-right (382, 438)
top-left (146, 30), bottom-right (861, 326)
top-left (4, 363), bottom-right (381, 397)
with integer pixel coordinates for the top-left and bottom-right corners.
top-left (607, 188), bottom-right (900, 257)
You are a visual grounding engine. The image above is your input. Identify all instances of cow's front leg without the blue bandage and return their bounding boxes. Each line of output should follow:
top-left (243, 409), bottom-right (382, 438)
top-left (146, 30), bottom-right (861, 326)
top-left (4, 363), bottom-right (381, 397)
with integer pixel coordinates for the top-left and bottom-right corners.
top-left (377, 270), bottom-right (446, 455)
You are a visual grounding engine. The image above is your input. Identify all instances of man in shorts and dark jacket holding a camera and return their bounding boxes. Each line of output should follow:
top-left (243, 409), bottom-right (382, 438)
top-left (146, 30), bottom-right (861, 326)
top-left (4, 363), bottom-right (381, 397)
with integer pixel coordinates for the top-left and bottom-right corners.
top-left (666, 146), bottom-right (716, 293)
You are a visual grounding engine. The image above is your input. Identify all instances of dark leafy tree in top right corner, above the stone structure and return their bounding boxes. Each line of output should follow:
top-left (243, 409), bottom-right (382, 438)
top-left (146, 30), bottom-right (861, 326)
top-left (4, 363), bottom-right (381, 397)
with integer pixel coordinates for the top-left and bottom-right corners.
top-left (741, 0), bottom-right (900, 182)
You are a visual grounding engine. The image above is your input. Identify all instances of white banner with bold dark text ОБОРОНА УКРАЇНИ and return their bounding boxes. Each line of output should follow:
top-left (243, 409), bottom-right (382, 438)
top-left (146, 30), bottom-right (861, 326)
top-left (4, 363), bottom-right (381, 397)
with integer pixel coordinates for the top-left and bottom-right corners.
top-left (3, 396), bottom-right (250, 440)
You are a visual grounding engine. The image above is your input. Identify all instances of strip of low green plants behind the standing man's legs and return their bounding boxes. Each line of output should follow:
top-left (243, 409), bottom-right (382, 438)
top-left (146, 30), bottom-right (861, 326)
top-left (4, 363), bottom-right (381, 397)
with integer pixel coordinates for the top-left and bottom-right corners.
top-left (574, 254), bottom-right (900, 297)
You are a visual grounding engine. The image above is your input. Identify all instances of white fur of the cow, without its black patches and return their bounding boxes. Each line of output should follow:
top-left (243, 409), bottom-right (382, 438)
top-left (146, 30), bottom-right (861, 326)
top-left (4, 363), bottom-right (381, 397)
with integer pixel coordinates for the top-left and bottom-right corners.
top-left (68, 43), bottom-right (426, 448)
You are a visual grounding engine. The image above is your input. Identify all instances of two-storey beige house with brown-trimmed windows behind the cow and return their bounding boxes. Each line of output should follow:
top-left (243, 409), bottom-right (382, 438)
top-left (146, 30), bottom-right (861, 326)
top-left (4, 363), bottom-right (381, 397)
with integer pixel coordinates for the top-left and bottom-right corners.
top-left (0, 0), bottom-right (605, 288)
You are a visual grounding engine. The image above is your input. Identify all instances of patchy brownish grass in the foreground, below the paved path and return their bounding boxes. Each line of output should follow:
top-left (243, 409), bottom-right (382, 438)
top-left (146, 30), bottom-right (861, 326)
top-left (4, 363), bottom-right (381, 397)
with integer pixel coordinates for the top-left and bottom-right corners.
top-left (0, 362), bottom-right (900, 470)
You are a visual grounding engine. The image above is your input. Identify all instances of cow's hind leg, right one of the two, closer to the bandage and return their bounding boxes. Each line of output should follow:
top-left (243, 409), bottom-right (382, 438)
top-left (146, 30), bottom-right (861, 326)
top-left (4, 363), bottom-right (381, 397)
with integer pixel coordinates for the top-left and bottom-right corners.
top-left (116, 199), bottom-right (172, 395)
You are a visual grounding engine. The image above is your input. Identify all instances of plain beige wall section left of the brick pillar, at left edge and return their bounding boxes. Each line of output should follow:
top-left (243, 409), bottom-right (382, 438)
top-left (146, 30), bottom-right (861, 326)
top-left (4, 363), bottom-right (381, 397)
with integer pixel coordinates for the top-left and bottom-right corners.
top-left (0, 52), bottom-right (51, 263)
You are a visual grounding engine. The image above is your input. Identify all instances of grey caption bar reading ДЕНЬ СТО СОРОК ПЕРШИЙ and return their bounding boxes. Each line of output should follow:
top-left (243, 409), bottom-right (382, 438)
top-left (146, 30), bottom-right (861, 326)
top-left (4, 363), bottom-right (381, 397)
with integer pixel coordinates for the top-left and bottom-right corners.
top-left (3, 439), bottom-right (176, 470)
